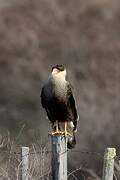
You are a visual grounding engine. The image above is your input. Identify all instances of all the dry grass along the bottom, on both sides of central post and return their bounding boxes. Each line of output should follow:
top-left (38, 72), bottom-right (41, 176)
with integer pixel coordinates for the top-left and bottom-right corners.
top-left (0, 136), bottom-right (120, 180)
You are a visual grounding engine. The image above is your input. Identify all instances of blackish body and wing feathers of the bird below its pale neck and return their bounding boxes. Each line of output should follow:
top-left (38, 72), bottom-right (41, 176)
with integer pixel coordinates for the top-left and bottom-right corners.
top-left (41, 83), bottom-right (78, 127)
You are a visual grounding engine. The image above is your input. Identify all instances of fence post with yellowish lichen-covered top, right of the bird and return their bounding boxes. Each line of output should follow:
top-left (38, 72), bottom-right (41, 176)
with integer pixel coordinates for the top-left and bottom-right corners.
top-left (102, 148), bottom-right (116, 180)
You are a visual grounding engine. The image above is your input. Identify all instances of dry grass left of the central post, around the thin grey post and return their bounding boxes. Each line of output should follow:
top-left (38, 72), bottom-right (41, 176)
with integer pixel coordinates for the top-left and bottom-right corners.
top-left (0, 142), bottom-right (51, 180)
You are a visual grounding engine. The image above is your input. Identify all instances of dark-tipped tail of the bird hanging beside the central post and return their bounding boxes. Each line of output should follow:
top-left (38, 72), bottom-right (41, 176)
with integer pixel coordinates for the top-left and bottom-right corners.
top-left (67, 131), bottom-right (76, 149)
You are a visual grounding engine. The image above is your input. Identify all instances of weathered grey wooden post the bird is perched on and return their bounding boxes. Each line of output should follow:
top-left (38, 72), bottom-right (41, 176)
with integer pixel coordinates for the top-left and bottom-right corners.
top-left (51, 135), bottom-right (67, 180)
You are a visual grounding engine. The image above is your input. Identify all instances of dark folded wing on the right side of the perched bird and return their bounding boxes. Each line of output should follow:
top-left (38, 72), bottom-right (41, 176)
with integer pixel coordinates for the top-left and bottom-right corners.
top-left (67, 84), bottom-right (78, 131)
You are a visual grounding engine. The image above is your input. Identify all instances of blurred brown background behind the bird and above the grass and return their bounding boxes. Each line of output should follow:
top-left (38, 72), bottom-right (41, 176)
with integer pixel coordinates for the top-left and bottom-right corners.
top-left (0, 0), bottom-right (120, 177)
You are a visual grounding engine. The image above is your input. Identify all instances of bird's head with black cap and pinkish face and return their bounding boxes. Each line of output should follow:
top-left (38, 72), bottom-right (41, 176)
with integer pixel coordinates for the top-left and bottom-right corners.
top-left (52, 65), bottom-right (66, 79)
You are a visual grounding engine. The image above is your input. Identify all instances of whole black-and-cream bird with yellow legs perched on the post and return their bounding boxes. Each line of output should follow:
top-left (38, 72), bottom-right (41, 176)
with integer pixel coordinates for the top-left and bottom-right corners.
top-left (41, 64), bottom-right (79, 149)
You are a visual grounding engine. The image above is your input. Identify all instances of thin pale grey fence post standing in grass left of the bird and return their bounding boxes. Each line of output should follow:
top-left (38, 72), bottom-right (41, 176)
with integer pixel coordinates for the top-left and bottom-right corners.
top-left (21, 147), bottom-right (29, 180)
